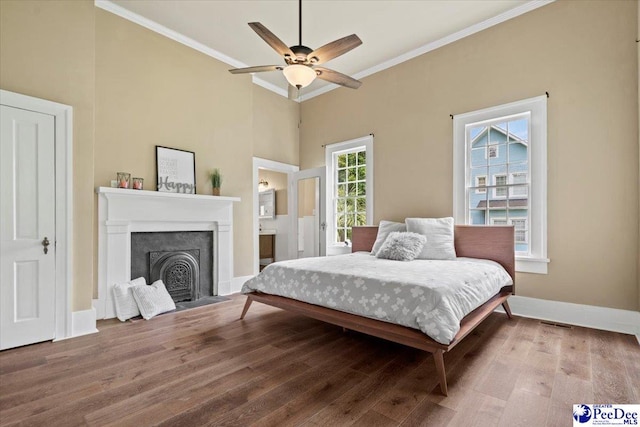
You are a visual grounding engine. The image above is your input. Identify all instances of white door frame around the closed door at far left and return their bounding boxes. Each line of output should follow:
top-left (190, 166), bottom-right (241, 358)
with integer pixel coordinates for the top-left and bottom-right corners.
top-left (0, 89), bottom-right (73, 341)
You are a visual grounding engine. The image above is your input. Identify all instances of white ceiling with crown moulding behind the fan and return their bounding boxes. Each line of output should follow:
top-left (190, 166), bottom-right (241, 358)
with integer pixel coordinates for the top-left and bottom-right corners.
top-left (101, 0), bottom-right (552, 100)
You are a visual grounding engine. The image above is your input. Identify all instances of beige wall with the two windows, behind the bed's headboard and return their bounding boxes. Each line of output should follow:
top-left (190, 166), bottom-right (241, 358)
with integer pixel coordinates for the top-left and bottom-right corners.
top-left (300, 0), bottom-right (640, 310)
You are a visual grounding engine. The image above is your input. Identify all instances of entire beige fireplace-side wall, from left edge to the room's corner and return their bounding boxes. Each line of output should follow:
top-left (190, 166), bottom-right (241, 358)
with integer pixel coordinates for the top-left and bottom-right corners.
top-left (0, 0), bottom-right (299, 310)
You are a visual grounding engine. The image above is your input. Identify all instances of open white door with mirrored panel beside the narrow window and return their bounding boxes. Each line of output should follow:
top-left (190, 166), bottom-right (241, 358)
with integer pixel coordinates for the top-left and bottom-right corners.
top-left (289, 167), bottom-right (327, 258)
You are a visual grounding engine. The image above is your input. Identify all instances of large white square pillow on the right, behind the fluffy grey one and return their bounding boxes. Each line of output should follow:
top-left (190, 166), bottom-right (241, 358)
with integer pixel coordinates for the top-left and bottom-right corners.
top-left (405, 217), bottom-right (456, 259)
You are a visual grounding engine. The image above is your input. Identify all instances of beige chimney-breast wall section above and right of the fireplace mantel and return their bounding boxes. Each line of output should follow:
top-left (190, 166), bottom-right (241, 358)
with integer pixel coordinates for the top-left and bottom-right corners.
top-left (95, 9), bottom-right (253, 288)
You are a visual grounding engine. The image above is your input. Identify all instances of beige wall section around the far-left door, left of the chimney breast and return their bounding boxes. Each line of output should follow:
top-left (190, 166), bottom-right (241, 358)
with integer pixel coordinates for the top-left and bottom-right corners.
top-left (0, 0), bottom-right (95, 310)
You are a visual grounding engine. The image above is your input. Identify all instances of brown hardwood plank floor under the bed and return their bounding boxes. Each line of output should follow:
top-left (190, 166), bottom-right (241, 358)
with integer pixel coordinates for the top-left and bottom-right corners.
top-left (0, 295), bottom-right (640, 426)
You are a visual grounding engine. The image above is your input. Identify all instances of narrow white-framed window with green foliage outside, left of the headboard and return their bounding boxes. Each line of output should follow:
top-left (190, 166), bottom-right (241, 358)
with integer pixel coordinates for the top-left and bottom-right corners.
top-left (325, 136), bottom-right (373, 246)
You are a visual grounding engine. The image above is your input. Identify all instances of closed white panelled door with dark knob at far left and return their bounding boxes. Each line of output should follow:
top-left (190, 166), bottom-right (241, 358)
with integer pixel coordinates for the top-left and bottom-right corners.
top-left (0, 105), bottom-right (56, 350)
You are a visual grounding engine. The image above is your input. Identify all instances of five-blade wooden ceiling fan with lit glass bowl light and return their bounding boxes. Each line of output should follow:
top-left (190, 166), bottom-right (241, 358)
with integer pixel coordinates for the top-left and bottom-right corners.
top-left (229, 0), bottom-right (362, 99)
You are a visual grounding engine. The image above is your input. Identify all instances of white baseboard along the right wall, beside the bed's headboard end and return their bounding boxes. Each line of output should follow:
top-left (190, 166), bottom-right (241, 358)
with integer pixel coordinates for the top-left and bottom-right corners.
top-left (499, 295), bottom-right (640, 343)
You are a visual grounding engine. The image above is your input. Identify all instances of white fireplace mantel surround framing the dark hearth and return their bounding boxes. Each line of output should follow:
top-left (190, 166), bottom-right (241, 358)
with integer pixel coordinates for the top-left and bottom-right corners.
top-left (94, 187), bottom-right (240, 319)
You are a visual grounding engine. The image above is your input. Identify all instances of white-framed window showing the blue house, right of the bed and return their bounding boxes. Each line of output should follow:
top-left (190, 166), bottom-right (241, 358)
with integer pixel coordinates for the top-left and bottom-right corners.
top-left (453, 96), bottom-right (549, 274)
